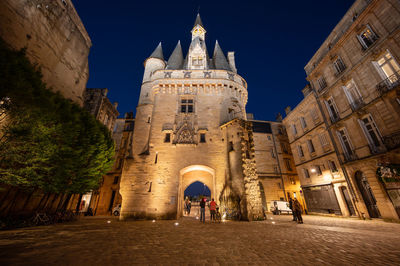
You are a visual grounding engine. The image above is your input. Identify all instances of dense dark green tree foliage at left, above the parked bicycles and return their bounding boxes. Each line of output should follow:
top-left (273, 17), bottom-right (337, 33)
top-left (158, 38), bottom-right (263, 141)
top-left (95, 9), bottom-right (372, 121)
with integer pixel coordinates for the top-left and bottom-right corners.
top-left (0, 40), bottom-right (114, 193)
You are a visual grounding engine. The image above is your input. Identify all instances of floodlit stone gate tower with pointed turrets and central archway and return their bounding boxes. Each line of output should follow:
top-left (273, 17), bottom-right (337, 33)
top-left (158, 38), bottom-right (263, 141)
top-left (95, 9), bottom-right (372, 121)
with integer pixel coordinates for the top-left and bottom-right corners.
top-left (120, 15), bottom-right (263, 220)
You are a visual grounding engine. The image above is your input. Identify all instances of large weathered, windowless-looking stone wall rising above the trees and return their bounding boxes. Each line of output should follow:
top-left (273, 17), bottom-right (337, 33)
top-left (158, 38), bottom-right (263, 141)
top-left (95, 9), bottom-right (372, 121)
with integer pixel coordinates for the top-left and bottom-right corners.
top-left (0, 0), bottom-right (92, 105)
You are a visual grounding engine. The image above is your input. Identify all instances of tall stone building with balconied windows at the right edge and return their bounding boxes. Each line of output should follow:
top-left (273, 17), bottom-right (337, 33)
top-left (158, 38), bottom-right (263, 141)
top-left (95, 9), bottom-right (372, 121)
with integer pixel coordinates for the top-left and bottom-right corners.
top-left (296, 0), bottom-right (400, 219)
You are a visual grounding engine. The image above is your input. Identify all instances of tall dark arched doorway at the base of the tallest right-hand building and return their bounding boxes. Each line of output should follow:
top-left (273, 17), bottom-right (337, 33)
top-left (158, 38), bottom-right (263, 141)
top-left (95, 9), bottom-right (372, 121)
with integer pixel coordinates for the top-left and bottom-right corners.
top-left (355, 171), bottom-right (381, 218)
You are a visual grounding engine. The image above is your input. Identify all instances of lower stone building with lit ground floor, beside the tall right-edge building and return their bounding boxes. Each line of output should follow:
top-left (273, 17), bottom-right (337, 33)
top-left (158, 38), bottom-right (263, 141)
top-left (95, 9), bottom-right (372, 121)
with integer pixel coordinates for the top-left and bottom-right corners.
top-left (283, 86), bottom-right (356, 216)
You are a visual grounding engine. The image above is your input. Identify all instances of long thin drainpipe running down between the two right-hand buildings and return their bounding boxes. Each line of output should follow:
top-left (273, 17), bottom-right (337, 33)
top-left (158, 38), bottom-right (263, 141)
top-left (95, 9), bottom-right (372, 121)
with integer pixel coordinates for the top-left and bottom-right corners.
top-left (310, 89), bottom-right (363, 219)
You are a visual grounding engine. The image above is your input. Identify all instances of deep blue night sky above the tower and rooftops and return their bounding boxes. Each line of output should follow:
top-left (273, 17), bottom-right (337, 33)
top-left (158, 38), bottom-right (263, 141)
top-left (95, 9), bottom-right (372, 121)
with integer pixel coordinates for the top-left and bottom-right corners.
top-left (74, 0), bottom-right (354, 120)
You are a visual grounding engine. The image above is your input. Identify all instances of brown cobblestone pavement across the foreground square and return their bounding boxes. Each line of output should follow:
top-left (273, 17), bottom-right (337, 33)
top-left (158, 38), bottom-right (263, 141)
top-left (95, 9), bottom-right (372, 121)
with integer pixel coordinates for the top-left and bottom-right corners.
top-left (0, 215), bottom-right (400, 265)
